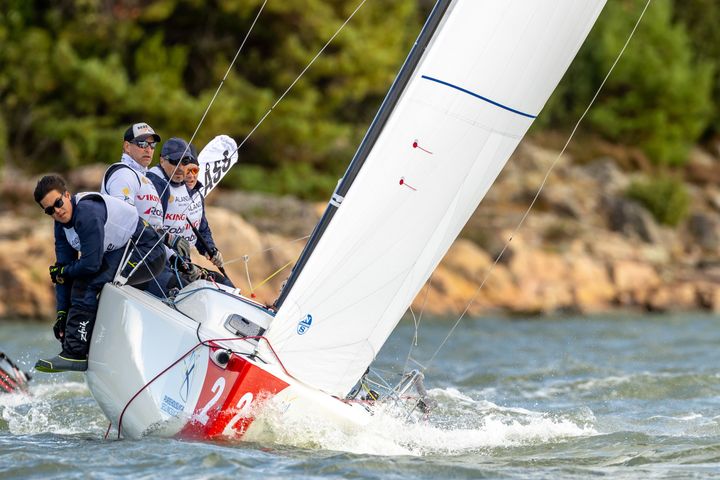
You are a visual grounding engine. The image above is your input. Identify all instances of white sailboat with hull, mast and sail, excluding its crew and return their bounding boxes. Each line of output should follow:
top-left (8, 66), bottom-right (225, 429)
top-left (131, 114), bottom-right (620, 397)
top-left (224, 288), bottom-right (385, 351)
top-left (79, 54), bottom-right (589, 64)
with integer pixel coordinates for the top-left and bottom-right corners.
top-left (87, 0), bottom-right (605, 438)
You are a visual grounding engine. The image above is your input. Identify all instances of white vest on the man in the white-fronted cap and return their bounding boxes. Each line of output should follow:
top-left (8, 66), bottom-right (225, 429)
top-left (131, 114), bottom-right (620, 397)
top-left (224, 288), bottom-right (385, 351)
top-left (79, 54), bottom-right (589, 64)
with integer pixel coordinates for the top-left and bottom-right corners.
top-left (100, 158), bottom-right (163, 229)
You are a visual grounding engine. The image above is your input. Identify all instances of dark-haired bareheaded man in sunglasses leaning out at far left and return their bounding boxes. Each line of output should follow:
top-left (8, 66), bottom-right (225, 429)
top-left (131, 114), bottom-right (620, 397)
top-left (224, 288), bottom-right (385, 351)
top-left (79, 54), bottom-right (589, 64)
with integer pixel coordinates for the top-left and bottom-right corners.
top-left (35, 175), bottom-right (166, 372)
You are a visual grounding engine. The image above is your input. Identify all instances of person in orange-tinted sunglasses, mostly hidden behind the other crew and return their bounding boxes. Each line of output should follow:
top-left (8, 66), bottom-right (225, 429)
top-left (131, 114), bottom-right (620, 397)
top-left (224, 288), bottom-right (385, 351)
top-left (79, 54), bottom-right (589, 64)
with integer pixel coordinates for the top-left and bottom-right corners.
top-left (185, 158), bottom-right (234, 287)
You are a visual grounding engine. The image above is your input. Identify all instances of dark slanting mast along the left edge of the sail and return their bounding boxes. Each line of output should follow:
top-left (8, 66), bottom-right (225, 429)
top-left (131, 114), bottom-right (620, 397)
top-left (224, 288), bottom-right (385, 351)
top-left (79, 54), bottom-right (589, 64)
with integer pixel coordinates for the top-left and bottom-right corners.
top-left (274, 0), bottom-right (452, 309)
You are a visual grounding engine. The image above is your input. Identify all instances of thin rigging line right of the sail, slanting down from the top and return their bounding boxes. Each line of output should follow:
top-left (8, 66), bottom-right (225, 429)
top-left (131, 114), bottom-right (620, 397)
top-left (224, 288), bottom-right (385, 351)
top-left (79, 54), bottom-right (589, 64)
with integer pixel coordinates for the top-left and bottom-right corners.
top-left (425, 0), bottom-right (652, 368)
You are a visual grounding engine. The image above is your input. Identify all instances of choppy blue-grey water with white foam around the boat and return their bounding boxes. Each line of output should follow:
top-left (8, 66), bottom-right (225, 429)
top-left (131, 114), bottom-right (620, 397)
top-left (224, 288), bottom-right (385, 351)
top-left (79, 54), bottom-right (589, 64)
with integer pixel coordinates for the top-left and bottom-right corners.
top-left (0, 315), bottom-right (720, 479)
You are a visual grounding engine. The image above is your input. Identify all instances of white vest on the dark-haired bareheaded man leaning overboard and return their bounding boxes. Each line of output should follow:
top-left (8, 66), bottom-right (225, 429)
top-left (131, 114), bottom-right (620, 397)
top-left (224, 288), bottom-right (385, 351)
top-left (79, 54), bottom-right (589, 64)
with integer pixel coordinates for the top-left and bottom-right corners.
top-left (63, 192), bottom-right (139, 252)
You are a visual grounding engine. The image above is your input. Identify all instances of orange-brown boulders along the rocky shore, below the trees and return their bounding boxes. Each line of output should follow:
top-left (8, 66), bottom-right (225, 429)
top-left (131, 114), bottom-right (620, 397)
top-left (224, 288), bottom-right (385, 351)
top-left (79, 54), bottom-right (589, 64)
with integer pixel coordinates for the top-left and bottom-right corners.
top-left (0, 141), bottom-right (720, 319)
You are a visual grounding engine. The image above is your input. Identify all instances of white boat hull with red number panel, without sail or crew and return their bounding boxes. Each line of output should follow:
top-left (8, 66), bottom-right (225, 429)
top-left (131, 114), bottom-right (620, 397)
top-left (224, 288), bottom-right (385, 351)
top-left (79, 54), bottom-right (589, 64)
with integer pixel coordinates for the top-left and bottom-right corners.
top-left (87, 282), bottom-right (371, 438)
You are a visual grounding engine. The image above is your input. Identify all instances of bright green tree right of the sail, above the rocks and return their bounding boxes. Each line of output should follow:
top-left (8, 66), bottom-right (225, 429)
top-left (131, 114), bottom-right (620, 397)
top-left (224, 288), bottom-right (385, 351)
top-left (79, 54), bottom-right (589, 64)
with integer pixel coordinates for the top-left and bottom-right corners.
top-left (544, 0), bottom-right (715, 165)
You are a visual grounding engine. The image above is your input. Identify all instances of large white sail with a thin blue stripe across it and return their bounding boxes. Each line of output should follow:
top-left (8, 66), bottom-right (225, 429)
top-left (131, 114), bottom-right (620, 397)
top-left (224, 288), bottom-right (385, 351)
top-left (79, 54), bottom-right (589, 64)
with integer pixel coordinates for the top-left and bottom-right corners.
top-left (263, 0), bottom-right (605, 396)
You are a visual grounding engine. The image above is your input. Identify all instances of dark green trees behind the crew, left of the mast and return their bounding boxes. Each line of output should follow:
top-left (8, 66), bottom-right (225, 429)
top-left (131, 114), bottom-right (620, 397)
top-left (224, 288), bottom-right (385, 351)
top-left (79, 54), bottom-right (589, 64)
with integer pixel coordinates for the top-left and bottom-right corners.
top-left (0, 0), bottom-right (420, 197)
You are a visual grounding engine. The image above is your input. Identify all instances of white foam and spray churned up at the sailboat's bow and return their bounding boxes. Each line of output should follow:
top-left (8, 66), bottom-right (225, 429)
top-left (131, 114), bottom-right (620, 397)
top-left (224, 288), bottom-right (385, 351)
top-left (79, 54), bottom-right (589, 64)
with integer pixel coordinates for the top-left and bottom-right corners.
top-left (239, 388), bottom-right (597, 456)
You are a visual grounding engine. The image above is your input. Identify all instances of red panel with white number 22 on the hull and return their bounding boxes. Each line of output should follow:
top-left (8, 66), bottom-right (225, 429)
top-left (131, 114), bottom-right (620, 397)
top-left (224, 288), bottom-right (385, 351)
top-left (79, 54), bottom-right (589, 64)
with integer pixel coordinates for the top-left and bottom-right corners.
top-left (179, 349), bottom-right (288, 439)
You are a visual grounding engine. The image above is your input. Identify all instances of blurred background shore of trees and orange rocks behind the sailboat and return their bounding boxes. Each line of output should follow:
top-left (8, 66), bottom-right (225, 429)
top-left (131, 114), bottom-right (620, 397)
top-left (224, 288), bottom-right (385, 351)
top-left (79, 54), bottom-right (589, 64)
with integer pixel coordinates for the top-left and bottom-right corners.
top-left (0, 0), bottom-right (720, 318)
